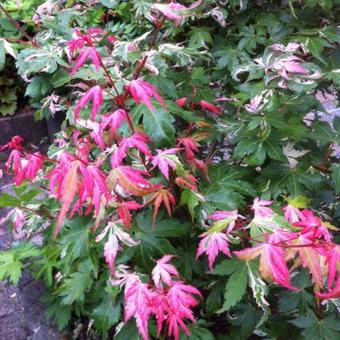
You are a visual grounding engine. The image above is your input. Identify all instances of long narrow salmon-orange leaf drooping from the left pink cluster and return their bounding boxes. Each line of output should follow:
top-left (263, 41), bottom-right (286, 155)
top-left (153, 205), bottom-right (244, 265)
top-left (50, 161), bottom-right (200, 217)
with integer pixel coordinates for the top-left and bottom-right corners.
top-left (53, 160), bottom-right (80, 238)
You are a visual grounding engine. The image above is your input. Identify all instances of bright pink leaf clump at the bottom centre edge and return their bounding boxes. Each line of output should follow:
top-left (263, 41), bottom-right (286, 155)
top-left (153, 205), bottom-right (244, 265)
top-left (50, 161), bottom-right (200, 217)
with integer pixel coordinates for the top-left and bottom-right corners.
top-left (113, 255), bottom-right (202, 340)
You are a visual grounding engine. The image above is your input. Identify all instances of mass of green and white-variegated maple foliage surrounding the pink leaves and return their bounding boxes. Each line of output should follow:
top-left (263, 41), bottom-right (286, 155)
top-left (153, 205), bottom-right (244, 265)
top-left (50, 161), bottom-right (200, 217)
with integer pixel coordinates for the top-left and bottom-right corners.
top-left (0, 0), bottom-right (340, 340)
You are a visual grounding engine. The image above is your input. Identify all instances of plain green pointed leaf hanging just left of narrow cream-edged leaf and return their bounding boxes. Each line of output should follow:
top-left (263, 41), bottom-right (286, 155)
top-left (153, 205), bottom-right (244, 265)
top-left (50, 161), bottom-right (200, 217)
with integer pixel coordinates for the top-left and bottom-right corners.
top-left (218, 261), bottom-right (248, 313)
